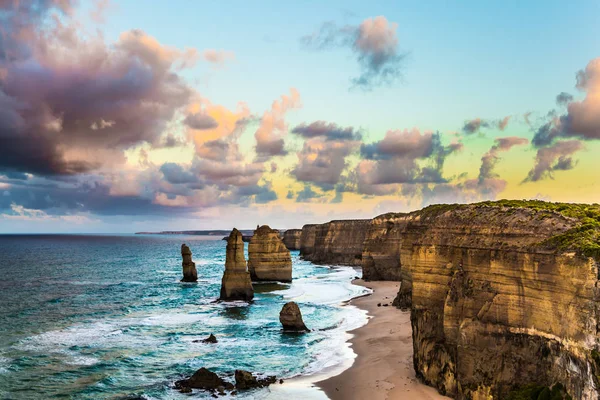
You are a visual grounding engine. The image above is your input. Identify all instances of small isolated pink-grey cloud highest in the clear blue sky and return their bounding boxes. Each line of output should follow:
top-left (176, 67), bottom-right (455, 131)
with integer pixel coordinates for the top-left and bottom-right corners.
top-left (301, 16), bottom-right (406, 90)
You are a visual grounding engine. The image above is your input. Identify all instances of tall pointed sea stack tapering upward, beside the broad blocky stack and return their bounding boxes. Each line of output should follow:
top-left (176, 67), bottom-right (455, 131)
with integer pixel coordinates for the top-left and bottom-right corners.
top-left (219, 228), bottom-right (254, 301)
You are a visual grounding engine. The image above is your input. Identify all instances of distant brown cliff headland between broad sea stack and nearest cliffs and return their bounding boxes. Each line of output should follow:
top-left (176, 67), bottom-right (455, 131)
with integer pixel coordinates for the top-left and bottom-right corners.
top-left (300, 219), bottom-right (371, 266)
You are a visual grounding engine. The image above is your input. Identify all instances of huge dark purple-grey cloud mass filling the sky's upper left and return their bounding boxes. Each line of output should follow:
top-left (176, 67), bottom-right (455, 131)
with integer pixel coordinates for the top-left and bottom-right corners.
top-left (0, 0), bottom-right (192, 175)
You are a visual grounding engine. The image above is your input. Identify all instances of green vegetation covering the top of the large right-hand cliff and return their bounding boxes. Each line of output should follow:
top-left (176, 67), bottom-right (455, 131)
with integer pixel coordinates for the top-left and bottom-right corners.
top-left (421, 200), bottom-right (600, 260)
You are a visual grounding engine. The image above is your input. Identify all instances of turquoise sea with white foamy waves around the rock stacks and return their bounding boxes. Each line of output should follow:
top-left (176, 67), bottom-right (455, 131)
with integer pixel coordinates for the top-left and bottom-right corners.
top-left (0, 235), bottom-right (367, 399)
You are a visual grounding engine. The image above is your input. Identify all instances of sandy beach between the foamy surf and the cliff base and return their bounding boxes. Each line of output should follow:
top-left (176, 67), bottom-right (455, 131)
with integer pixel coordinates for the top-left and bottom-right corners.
top-left (316, 280), bottom-right (448, 400)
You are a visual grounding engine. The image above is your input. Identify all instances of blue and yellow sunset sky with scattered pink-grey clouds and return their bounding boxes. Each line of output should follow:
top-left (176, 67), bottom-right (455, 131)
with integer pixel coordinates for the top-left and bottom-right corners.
top-left (0, 0), bottom-right (600, 233)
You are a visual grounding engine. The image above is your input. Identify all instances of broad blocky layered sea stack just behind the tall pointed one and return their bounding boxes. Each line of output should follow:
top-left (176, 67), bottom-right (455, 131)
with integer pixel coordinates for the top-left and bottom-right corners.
top-left (248, 225), bottom-right (292, 282)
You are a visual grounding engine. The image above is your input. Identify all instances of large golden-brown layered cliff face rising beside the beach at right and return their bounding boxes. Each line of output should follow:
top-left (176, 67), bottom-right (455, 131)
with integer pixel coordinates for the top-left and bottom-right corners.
top-left (384, 205), bottom-right (600, 399)
